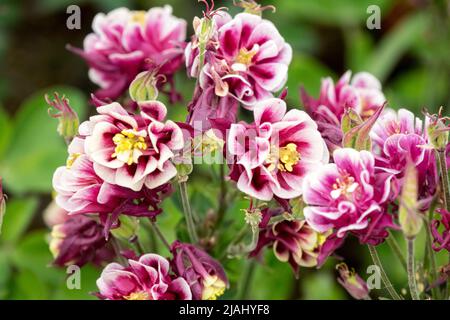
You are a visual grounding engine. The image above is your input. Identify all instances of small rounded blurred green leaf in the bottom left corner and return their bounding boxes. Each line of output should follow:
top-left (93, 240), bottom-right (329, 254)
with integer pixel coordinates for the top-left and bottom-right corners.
top-left (12, 270), bottom-right (49, 300)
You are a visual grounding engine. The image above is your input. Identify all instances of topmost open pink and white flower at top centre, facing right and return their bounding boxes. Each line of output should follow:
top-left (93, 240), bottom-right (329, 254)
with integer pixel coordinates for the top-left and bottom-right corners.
top-left (185, 12), bottom-right (292, 118)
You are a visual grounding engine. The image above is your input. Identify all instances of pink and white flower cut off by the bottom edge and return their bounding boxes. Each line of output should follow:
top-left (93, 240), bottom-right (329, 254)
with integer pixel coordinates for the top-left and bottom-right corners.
top-left (97, 253), bottom-right (192, 300)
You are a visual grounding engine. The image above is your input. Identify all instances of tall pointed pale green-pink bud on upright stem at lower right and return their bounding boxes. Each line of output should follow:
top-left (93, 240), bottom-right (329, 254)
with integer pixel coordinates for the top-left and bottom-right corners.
top-left (399, 162), bottom-right (423, 239)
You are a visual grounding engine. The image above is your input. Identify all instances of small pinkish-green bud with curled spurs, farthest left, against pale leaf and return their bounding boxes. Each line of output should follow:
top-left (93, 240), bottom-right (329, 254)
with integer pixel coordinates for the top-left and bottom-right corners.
top-left (45, 92), bottom-right (80, 142)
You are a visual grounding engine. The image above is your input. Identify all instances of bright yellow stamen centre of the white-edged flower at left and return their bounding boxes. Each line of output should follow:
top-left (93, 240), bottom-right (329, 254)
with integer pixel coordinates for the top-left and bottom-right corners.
top-left (111, 129), bottom-right (147, 165)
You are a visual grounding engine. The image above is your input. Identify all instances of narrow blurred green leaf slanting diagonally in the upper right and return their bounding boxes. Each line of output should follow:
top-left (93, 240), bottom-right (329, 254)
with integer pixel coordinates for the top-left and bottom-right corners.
top-left (366, 13), bottom-right (428, 82)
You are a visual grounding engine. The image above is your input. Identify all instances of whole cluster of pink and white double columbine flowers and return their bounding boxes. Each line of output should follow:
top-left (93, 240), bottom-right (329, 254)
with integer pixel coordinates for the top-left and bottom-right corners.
top-left (43, 1), bottom-right (450, 300)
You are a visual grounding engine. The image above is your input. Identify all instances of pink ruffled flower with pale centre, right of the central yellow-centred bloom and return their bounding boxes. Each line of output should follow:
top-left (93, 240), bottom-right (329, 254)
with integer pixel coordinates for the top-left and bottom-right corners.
top-left (303, 148), bottom-right (395, 260)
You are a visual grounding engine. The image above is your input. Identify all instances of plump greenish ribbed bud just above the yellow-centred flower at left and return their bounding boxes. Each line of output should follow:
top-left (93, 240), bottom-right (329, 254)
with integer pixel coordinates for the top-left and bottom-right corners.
top-left (129, 70), bottom-right (164, 102)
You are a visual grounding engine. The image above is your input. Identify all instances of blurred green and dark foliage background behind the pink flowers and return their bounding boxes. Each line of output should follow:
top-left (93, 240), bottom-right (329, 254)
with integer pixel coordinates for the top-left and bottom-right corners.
top-left (0, 0), bottom-right (450, 299)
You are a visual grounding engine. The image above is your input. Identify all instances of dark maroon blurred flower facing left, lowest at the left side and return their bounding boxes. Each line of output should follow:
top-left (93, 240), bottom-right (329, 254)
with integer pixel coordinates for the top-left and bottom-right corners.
top-left (50, 215), bottom-right (113, 267)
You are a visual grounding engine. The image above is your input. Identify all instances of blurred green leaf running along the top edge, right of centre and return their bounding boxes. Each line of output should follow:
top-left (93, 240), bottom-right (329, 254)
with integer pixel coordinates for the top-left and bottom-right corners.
top-left (276, 0), bottom-right (392, 26)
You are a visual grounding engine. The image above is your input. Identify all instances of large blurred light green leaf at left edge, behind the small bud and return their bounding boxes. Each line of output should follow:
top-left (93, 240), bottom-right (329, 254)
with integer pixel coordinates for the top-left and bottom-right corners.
top-left (0, 87), bottom-right (86, 193)
